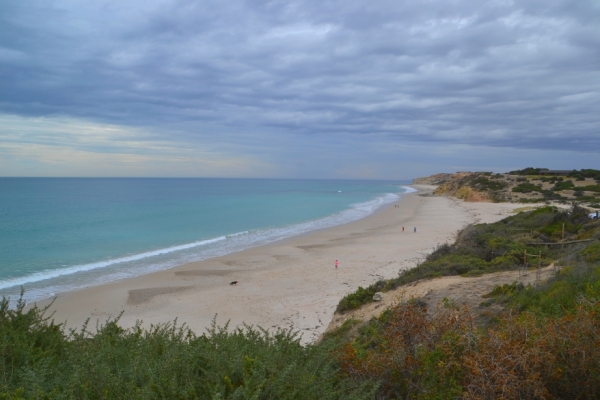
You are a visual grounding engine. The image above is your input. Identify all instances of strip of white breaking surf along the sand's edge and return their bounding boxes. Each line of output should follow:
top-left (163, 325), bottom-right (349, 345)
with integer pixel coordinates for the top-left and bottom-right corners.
top-left (8, 184), bottom-right (408, 303)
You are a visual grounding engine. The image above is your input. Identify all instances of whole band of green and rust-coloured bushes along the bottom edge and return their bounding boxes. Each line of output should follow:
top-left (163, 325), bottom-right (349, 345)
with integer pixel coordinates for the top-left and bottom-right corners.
top-left (7, 282), bottom-right (600, 399)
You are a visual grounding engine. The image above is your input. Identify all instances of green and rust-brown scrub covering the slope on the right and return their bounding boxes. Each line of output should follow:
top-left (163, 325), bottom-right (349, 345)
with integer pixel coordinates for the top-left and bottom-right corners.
top-left (329, 207), bottom-right (600, 399)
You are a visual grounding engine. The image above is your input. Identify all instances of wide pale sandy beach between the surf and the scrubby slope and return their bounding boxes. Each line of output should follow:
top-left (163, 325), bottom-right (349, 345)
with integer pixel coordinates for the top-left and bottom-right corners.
top-left (38, 185), bottom-right (519, 343)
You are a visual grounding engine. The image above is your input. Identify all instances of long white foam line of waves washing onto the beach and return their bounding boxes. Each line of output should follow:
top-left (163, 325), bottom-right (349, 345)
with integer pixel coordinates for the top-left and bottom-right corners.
top-left (0, 186), bottom-right (408, 301)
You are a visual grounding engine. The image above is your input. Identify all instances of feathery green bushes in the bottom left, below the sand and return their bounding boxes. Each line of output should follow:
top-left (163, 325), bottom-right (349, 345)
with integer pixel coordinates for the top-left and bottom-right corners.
top-left (0, 299), bottom-right (375, 399)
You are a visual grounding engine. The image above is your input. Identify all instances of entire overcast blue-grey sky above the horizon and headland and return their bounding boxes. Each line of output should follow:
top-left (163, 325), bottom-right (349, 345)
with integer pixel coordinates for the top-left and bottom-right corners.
top-left (0, 0), bottom-right (600, 179)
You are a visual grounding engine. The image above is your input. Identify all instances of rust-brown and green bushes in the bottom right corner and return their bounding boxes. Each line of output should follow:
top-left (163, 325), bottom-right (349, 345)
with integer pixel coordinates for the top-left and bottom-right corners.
top-left (337, 302), bottom-right (600, 399)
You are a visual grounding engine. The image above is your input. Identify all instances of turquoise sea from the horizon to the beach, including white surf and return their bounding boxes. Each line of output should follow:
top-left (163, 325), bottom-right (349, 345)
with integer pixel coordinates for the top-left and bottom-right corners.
top-left (0, 178), bottom-right (408, 301)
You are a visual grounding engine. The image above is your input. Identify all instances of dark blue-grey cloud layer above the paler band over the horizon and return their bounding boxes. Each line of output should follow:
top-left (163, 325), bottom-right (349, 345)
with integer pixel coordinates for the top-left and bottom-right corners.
top-left (0, 0), bottom-right (600, 152)
